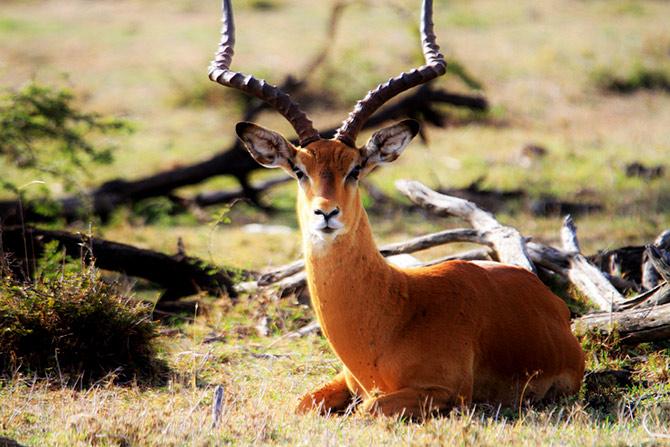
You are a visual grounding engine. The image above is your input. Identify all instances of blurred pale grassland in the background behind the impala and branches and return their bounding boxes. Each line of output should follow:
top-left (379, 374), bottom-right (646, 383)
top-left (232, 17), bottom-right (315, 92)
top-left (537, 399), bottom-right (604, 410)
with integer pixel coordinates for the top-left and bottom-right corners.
top-left (0, 0), bottom-right (670, 268)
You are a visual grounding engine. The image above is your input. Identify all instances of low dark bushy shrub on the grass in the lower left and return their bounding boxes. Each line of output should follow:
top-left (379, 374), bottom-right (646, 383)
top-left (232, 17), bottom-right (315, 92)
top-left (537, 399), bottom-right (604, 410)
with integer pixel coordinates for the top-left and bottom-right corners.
top-left (0, 253), bottom-right (165, 384)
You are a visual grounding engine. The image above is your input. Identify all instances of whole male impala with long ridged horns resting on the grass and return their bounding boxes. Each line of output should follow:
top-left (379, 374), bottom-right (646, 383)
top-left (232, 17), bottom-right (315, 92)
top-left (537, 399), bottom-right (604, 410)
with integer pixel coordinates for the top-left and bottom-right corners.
top-left (209, 0), bottom-right (584, 416)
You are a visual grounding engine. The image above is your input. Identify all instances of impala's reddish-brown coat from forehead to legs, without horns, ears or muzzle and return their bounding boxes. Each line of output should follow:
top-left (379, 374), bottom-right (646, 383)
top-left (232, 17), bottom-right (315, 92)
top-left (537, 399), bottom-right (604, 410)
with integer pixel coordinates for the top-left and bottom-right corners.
top-left (297, 141), bottom-right (584, 416)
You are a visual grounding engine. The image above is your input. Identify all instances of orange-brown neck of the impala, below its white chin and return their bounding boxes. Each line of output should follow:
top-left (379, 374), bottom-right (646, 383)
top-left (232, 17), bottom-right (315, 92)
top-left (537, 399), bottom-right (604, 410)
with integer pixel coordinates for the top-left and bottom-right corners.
top-left (298, 191), bottom-right (407, 372)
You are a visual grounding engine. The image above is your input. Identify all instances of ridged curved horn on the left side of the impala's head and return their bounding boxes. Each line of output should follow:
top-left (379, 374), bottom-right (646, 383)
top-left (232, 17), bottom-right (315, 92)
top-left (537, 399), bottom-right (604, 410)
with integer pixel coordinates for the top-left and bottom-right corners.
top-left (209, 0), bottom-right (321, 147)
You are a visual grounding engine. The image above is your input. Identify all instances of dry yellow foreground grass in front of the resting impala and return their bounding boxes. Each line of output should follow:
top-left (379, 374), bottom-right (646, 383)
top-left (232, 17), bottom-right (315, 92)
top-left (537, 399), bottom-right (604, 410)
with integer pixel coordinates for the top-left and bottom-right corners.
top-left (0, 314), bottom-right (670, 446)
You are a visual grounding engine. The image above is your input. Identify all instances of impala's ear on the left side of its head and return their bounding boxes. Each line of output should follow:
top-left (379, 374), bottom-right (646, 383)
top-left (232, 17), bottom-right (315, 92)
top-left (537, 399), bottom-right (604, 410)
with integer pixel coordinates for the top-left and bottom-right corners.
top-left (235, 121), bottom-right (296, 172)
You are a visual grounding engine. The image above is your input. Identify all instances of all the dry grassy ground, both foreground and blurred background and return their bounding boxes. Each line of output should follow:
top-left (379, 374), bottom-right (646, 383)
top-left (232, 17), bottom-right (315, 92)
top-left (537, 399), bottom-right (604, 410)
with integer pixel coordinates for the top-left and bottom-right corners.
top-left (0, 0), bottom-right (670, 445)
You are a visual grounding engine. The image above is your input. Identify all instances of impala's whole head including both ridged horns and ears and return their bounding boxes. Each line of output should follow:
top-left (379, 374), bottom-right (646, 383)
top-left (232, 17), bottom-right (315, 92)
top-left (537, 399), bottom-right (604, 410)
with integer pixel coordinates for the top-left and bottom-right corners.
top-left (209, 0), bottom-right (446, 245)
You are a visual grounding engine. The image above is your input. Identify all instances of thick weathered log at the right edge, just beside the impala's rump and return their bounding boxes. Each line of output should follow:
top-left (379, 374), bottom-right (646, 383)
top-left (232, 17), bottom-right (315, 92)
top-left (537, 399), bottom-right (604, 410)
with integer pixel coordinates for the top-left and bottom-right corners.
top-left (572, 304), bottom-right (670, 344)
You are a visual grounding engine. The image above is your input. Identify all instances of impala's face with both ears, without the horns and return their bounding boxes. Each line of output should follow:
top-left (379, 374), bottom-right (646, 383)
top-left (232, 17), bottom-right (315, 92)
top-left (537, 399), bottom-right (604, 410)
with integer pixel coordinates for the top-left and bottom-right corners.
top-left (236, 120), bottom-right (419, 244)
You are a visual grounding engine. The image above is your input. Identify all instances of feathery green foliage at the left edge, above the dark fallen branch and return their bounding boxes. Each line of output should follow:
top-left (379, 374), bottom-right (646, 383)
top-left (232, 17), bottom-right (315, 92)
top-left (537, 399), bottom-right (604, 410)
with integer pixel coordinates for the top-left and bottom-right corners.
top-left (0, 84), bottom-right (129, 194)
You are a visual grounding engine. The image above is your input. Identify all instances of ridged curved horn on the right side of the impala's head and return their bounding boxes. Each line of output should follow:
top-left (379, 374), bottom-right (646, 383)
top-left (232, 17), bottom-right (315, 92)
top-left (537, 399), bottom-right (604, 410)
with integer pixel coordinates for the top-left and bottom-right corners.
top-left (335, 0), bottom-right (447, 147)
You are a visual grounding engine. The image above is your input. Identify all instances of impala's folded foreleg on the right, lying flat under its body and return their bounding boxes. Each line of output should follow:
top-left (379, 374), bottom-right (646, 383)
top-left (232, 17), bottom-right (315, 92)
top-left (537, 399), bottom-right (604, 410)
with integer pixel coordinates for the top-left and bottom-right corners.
top-left (362, 388), bottom-right (472, 419)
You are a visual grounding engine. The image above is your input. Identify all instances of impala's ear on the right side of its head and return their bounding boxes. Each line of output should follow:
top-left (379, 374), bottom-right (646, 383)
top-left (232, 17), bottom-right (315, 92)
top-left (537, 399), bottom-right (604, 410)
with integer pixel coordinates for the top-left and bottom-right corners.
top-left (361, 120), bottom-right (420, 172)
